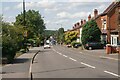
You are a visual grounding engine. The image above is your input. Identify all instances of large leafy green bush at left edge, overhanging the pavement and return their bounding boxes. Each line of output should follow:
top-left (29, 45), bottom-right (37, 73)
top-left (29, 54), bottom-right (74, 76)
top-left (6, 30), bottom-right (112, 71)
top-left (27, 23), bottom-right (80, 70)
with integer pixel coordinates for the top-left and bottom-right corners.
top-left (2, 23), bottom-right (24, 63)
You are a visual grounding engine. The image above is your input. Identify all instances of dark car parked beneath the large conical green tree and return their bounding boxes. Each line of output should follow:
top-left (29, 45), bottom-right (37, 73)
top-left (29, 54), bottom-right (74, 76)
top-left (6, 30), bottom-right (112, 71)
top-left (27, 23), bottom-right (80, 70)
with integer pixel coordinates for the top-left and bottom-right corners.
top-left (84, 42), bottom-right (104, 50)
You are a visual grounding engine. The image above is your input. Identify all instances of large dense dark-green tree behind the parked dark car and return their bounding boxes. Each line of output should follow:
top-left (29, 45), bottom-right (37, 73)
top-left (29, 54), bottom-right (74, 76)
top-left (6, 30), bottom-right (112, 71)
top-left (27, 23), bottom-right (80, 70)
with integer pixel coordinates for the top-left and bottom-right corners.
top-left (82, 20), bottom-right (101, 45)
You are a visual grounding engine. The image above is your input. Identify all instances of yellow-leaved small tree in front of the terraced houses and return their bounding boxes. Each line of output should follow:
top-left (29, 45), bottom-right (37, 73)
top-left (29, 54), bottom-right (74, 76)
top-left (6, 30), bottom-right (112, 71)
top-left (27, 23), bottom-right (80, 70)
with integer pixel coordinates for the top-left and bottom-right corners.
top-left (65, 31), bottom-right (78, 44)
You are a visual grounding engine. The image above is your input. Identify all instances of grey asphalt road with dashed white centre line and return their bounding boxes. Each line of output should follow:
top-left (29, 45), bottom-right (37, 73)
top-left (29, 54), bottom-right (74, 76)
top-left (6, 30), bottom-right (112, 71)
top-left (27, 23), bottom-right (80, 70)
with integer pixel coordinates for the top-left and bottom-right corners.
top-left (32, 46), bottom-right (120, 78)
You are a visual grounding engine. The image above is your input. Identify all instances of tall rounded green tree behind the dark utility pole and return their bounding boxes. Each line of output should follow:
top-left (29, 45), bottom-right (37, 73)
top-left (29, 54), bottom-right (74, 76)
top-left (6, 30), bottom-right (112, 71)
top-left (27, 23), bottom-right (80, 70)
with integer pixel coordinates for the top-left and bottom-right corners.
top-left (14, 10), bottom-right (45, 38)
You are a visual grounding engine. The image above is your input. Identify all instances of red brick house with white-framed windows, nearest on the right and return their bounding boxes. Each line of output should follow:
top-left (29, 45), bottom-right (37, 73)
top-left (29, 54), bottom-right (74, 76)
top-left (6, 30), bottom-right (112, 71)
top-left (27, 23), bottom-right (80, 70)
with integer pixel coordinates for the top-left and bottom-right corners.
top-left (94, 2), bottom-right (120, 52)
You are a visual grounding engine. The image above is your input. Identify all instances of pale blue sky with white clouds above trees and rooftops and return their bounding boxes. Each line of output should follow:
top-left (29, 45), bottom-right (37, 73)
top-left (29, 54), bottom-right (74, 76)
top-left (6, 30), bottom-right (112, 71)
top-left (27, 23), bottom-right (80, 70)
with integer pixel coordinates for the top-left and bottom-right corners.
top-left (0, 0), bottom-right (114, 30)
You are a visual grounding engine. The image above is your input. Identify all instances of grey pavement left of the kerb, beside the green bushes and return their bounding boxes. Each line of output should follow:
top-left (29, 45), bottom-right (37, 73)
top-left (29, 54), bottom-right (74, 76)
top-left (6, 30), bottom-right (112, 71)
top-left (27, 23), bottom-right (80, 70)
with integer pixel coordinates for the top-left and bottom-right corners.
top-left (1, 47), bottom-right (41, 79)
